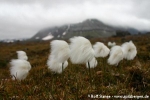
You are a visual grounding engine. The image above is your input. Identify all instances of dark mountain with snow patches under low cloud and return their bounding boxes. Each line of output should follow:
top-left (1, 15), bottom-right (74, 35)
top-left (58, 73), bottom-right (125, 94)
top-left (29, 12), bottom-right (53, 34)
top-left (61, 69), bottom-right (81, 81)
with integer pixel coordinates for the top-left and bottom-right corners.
top-left (30, 19), bottom-right (137, 40)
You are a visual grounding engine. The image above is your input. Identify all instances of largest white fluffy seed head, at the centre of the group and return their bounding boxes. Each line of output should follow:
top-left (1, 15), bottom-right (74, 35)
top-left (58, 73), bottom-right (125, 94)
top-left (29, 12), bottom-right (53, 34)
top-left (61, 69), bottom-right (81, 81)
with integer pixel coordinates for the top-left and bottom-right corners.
top-left (70, 36), bottom-right (94, 64)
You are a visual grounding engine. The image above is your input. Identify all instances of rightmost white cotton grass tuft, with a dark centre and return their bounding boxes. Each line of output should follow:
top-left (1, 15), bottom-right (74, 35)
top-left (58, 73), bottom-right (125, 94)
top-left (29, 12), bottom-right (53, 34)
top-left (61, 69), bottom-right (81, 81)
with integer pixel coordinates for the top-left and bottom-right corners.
top-left (121, 41), bottom-right (137, 60)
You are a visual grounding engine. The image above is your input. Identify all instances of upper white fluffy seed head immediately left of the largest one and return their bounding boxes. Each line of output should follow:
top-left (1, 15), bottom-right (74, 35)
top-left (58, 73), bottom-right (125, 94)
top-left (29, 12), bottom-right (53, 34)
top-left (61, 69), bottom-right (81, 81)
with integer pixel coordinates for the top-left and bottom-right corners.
top-left (51, 40), bottom-right (70, 63)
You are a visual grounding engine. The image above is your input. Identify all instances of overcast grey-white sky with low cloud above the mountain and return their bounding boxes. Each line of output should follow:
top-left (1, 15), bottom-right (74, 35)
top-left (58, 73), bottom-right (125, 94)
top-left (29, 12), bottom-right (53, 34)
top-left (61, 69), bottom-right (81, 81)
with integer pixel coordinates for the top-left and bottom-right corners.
top-left (0, 0), bottom-right (150, 39)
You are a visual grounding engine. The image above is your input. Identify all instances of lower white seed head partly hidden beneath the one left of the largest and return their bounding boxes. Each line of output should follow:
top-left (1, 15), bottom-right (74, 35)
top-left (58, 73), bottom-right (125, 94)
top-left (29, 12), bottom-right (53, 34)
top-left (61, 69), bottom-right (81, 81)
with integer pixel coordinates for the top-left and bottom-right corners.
top-left (47, 57), bottom-right (68, 74)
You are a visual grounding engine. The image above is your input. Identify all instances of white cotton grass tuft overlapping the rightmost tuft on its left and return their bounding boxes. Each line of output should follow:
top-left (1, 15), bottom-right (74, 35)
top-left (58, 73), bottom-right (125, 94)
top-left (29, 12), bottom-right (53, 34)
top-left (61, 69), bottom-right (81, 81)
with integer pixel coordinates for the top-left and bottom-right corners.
top-left (108, 46), bottom-right (124, 65)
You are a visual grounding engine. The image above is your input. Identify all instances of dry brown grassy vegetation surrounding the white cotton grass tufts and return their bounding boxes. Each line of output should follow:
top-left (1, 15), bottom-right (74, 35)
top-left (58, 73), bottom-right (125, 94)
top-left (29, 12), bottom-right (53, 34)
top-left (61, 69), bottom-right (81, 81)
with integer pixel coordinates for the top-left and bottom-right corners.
top-left (0, 36), bottom-right (150, 100)
